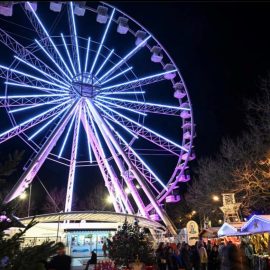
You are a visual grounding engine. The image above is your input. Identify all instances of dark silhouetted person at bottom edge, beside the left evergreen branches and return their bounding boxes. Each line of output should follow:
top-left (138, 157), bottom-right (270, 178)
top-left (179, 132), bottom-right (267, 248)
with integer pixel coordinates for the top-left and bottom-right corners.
top-left (48, 243), bottom-right (71, 270)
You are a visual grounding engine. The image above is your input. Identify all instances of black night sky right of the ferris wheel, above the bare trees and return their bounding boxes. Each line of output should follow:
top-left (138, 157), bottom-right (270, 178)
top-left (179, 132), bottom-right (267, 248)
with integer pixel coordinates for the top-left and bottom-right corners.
top-left (0, 1), bottom-right (270, 206)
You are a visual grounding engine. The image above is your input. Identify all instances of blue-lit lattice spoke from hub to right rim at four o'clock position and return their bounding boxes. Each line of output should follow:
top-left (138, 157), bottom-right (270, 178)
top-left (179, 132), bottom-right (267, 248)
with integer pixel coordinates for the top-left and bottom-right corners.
top-left (95, 104), bottom-right (188, 156)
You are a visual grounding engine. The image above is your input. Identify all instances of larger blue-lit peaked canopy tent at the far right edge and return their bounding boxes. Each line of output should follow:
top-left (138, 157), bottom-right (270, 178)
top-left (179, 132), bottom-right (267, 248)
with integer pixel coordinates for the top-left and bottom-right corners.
top-left (241, 215), bottom-right (270, 234)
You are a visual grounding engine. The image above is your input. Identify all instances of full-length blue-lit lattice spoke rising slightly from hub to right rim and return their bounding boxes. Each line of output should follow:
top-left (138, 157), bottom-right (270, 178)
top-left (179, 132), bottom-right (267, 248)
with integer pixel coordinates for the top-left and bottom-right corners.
top-left (100, 69), bottom-right (176, 93)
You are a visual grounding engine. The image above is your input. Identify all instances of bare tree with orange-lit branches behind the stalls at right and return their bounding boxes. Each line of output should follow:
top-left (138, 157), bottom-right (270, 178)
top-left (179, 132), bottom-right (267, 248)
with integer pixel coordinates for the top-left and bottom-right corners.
top-left (186, 79), bottom-right (270, 219)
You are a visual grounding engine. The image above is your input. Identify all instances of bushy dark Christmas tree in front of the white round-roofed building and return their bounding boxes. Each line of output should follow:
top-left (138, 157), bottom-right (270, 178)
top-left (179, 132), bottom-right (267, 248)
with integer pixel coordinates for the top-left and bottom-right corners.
top-left (108, 221), bottom-right (154, 266)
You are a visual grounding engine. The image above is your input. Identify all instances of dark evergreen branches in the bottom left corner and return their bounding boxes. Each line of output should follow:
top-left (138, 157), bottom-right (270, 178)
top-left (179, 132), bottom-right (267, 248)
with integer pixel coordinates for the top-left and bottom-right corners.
top-left (0, 206), bottom-right (58, 270)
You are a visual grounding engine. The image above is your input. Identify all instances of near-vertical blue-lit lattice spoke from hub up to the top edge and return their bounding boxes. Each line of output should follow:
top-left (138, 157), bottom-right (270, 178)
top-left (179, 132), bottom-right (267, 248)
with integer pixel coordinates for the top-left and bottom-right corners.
top-left (68, 2), bottom-right (81, 73)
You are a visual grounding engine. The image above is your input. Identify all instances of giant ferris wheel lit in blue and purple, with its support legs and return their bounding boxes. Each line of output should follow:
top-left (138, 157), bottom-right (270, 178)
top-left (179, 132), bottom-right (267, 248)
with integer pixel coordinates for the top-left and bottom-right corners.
top-left (0, 2), bottom-right (195, 233)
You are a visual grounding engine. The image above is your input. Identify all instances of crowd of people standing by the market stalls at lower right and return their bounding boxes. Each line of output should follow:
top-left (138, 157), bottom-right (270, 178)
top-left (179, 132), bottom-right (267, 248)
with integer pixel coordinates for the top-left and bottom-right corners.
top-left (156, 240), bottom-right (253, 270)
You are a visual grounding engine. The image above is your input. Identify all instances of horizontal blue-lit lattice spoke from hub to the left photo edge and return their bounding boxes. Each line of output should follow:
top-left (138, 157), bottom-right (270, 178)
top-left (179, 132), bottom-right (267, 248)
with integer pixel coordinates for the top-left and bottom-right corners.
top-left (0, 94), bottom-right (68, 107)
